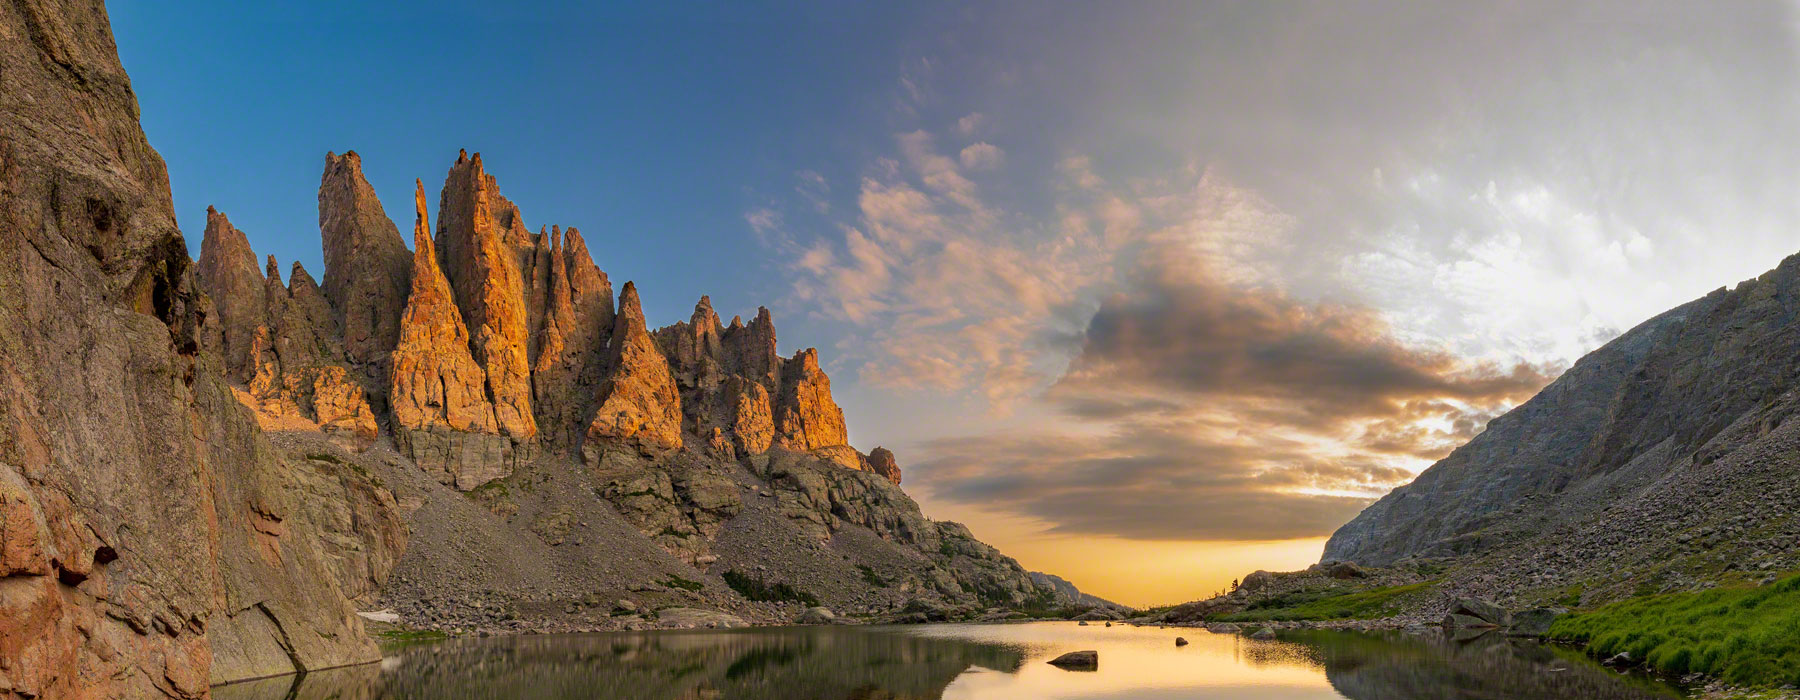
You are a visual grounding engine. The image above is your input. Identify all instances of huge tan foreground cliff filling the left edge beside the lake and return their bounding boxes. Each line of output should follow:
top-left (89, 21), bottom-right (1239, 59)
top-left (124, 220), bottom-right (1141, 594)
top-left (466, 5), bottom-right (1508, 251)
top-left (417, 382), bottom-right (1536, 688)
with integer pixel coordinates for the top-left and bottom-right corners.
top-left (0, 0), bottom-right (401, 698)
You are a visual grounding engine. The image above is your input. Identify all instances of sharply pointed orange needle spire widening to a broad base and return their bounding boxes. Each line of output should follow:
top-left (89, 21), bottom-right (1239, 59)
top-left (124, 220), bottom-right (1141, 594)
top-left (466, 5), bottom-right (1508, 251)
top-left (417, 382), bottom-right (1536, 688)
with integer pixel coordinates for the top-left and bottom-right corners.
top-left (391, 184), bottom-right (511, 489)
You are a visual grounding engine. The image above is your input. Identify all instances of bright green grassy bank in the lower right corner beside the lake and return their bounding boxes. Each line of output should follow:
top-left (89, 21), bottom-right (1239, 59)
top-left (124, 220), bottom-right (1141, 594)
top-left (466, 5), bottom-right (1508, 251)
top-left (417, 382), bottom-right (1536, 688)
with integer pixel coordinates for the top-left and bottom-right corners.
top-left (1550, 576), bottom-right (1800, 686)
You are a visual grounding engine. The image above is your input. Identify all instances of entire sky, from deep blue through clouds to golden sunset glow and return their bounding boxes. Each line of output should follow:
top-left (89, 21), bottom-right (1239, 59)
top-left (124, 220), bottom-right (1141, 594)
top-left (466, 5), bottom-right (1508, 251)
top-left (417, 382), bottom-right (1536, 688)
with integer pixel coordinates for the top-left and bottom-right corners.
top-left (110, 2), bottom-right (1800, 605)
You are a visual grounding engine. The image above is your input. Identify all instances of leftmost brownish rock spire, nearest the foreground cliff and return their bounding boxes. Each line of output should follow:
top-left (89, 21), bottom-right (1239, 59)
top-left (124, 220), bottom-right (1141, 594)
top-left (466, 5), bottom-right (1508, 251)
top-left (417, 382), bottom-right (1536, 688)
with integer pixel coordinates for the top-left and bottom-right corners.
top-left (194, 207), bottom-right (265, 381)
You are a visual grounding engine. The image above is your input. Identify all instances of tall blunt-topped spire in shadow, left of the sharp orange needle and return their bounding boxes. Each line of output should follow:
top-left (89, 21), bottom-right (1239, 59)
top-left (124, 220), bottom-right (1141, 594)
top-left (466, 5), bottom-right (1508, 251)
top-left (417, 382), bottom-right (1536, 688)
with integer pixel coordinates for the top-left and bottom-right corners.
top-left (319, 151), bottom-right (412, 397)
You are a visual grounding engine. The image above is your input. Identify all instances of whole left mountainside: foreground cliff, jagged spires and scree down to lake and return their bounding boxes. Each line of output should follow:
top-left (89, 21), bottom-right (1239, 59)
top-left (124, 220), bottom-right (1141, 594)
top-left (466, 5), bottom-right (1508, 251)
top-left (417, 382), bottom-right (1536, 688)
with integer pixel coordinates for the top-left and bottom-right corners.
top-left (0, 0), bottom-right (1080, 698)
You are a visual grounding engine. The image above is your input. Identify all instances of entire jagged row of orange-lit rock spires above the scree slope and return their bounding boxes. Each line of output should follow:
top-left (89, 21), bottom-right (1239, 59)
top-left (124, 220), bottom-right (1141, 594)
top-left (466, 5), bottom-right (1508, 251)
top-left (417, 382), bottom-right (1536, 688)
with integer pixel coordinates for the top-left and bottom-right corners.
top-left (198, 140), bottom-right (898, 489)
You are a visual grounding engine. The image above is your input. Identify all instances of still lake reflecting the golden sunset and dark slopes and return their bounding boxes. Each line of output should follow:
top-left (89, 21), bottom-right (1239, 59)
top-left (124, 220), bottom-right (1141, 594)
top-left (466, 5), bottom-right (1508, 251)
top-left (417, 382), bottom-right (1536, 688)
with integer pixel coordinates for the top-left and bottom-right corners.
top-left (214, 623), bottom-right (1681, 700)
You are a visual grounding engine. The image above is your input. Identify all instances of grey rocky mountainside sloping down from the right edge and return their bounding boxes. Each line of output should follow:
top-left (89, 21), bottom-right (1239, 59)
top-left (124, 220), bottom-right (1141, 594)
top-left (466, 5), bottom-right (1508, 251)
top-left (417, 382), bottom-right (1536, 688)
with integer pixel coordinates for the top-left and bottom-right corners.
top-left (1325, 257), bottom-right (1800, 605)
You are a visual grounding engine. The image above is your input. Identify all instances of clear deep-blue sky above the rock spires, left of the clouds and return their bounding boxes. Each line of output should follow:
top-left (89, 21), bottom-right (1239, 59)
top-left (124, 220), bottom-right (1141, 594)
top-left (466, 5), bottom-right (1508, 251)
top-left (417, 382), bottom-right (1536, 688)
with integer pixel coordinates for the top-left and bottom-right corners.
top-left (112, 2), bottom-right (909, 335)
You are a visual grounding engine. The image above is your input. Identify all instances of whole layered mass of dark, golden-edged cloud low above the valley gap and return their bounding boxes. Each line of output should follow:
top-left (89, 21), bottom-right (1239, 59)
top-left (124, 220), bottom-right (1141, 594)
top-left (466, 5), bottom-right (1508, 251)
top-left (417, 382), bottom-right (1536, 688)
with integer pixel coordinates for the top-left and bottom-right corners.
top-left (914, 229), bottom-right (1555, 540)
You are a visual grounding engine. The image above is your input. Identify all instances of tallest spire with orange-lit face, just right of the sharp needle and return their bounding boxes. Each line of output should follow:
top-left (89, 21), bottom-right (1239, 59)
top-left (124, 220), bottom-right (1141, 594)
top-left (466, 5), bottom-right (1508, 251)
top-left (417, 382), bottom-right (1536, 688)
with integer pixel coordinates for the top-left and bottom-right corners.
top-left (437, 153), bottom-right (538, 439)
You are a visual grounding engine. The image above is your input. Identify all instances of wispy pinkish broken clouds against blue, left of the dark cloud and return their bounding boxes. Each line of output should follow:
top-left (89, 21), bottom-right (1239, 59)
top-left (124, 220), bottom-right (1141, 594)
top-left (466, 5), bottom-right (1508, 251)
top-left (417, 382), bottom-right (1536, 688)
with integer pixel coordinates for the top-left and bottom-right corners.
top-left (777, 130), bottom-right (1130, 401)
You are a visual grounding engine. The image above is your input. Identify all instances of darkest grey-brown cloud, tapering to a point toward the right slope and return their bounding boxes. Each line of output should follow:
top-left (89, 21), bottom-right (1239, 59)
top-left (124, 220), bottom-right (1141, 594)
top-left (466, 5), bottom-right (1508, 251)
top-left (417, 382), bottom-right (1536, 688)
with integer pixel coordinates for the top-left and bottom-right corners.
top-left (1051, 247), bottom-right (1548, 425)
